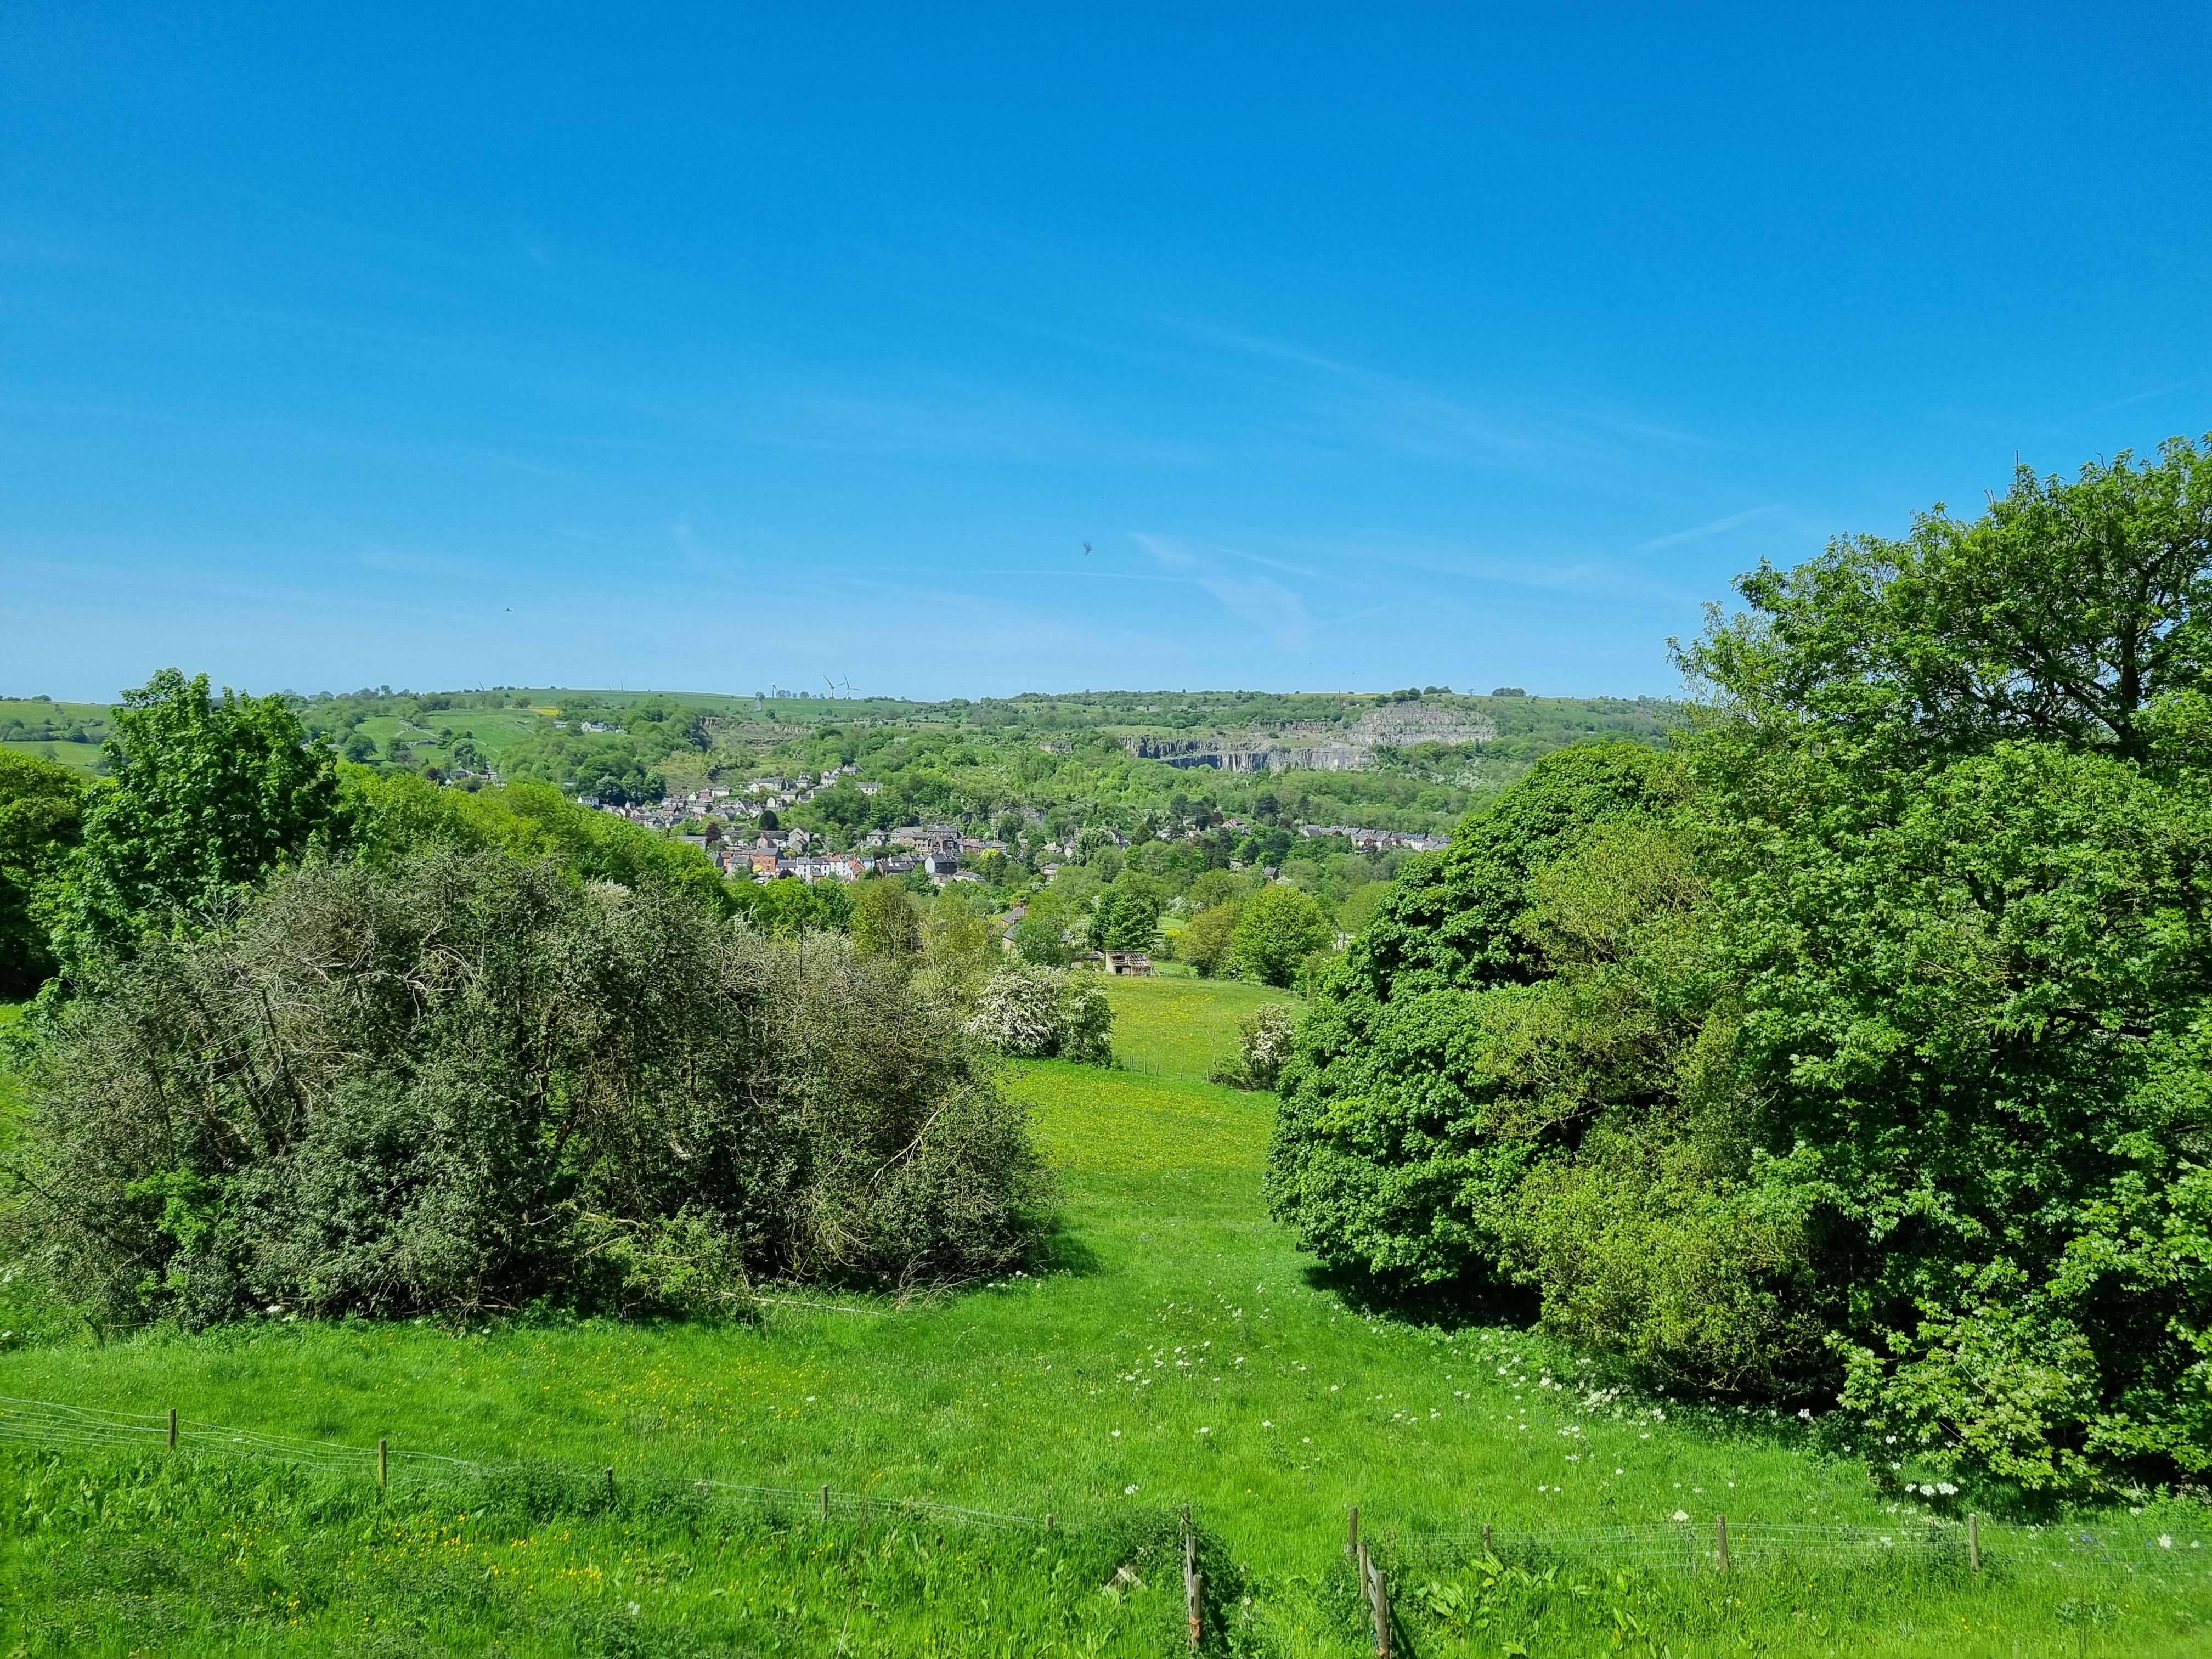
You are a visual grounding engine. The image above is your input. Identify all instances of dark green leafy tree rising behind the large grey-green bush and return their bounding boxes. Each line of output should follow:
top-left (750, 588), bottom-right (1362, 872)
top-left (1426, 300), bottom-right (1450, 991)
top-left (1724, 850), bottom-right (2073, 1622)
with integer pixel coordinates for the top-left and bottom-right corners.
top-left (73, 668), bottom-right (345, 960)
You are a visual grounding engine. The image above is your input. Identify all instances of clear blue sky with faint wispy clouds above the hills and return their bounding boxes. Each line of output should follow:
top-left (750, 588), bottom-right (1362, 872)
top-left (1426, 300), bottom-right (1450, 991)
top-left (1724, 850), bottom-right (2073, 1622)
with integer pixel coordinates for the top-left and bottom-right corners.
top-left (0, 0), bottom-right (2212, 697)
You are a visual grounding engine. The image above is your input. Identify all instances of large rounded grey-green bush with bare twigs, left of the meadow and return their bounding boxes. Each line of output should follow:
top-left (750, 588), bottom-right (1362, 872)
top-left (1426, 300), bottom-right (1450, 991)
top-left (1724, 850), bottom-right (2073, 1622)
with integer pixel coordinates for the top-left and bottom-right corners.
top-left (4, 849), bottom-right (1044, 1325)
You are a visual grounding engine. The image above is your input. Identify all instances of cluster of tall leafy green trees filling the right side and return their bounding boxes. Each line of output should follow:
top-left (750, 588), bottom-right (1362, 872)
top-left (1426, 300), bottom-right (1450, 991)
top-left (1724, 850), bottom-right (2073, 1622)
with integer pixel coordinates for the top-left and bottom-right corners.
top-left (1269, 442), bottom-right (2212, 1489)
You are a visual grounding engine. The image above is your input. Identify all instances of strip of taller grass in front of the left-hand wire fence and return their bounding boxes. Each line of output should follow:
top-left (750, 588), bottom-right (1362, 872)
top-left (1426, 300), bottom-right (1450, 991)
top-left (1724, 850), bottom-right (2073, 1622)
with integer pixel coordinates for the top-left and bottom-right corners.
top-left (0, 1449), bottom-right (1237, 1659)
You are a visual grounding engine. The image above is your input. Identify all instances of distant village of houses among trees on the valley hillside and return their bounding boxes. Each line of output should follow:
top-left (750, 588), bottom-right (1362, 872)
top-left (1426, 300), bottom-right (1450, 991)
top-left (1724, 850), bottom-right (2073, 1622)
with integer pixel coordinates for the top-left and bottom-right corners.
top-left (584, 765), bottom-right (1447, 887)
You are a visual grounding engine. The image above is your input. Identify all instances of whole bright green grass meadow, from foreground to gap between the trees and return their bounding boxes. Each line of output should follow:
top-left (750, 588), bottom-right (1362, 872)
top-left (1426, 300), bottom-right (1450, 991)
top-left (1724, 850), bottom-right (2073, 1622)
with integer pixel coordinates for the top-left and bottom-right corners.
top-left (0, 980), bottom-right (2212, 1659)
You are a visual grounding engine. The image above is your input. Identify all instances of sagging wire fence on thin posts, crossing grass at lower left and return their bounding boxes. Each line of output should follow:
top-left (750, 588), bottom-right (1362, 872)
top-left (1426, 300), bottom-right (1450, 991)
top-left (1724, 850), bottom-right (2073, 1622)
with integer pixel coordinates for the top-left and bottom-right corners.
top-left (0, 1396), bottom-right (1068, 1531)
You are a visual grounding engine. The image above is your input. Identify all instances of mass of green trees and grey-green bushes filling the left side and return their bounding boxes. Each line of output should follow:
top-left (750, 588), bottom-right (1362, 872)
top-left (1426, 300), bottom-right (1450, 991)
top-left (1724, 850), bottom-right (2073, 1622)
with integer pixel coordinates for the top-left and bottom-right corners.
top-left (0, 673), bottom-right (1044, 1325)
